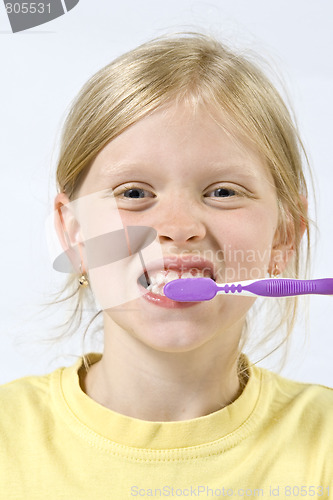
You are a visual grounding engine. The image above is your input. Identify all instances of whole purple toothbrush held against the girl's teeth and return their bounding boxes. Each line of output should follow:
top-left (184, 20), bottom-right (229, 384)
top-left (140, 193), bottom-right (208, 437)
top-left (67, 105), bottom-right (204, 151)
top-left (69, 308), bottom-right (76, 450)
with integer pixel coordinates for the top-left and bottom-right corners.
top-left (163, 278), bottom-right (333, 302)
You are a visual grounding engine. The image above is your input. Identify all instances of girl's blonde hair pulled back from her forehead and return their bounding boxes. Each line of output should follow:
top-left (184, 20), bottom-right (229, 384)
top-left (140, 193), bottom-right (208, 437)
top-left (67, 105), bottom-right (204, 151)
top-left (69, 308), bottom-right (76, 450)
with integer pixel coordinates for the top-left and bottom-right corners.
top-left (51, 33), bottom-right (311, 368)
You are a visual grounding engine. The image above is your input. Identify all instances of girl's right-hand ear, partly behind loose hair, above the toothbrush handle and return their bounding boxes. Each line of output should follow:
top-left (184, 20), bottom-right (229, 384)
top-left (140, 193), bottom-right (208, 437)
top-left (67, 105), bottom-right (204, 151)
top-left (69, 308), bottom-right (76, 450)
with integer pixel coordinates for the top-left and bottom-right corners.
top-left (268, 194), bottom-right (308, 274)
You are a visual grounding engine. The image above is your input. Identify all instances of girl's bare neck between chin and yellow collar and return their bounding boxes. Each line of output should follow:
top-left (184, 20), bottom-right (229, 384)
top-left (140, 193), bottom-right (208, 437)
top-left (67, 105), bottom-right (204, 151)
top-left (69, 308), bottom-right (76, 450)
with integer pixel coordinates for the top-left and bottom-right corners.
top-left (80, 314), bottom-right (242, 422)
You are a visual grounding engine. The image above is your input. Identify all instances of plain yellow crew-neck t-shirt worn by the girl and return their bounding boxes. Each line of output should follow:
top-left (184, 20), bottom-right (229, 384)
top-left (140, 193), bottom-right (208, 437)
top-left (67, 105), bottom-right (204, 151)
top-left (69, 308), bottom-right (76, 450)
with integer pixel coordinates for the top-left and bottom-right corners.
top-left (0, 353), bottom-right (333, 500)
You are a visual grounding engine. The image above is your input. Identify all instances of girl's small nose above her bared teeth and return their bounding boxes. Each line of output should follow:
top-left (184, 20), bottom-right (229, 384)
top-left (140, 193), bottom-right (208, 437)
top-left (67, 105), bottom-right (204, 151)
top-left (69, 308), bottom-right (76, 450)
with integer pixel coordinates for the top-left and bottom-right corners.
top-left (155, 197), bottom-right (206, 246)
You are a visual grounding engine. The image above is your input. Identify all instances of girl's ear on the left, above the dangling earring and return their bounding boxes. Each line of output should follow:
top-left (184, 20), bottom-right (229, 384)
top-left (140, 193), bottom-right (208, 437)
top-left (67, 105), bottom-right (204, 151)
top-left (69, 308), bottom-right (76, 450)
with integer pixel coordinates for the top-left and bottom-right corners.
top-left (54, 193), bottom-right (85, 273)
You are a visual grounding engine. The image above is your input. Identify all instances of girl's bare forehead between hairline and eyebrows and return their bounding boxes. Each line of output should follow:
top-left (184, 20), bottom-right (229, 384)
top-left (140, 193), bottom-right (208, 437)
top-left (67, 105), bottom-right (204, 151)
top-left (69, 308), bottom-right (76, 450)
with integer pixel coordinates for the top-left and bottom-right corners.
top-left (80, 103), bottom-right (273, 191)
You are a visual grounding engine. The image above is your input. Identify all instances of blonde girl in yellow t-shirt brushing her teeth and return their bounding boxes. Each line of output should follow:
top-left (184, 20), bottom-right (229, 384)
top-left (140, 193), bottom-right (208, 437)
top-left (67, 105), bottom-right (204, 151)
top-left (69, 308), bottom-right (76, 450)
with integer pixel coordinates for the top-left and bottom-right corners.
top-left (0, 34), bottom-right (333, 499)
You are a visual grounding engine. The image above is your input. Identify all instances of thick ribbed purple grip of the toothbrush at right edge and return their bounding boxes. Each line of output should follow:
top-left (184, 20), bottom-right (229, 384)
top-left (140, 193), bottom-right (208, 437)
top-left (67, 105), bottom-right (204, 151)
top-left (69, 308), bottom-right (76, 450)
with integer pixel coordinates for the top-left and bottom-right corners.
top-left (242, 278), bottom-right (333, 297)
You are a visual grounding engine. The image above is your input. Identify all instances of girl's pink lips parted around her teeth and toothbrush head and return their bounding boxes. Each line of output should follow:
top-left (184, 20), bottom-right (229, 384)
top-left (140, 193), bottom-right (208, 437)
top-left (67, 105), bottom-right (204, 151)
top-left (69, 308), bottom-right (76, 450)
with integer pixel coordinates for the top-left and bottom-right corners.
top-left (137, 255), bottom-right (216, 309)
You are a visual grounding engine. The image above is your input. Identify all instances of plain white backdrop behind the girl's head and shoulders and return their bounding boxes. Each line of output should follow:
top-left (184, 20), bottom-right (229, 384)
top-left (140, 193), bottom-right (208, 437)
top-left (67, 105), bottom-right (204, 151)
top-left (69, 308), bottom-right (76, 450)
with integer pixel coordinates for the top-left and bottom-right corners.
top-left (0, 0), bottom-right (333, 386)
